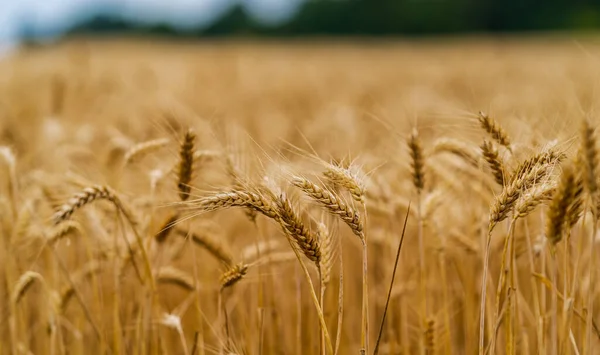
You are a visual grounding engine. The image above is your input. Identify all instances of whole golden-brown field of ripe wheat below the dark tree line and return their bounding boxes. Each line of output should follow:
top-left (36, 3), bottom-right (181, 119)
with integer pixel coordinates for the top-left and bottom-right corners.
top-left (0, 37), bottom-right (600, 355)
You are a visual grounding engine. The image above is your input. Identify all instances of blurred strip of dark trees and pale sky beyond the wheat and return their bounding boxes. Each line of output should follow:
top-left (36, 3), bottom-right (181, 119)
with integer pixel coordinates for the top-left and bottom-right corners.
top-left (0, 0), bottom-right (600, 50)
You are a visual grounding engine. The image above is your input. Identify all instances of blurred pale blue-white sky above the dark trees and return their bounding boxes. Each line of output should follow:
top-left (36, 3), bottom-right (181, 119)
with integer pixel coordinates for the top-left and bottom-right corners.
top-left (0, 0), bottom-right (305, 49)
